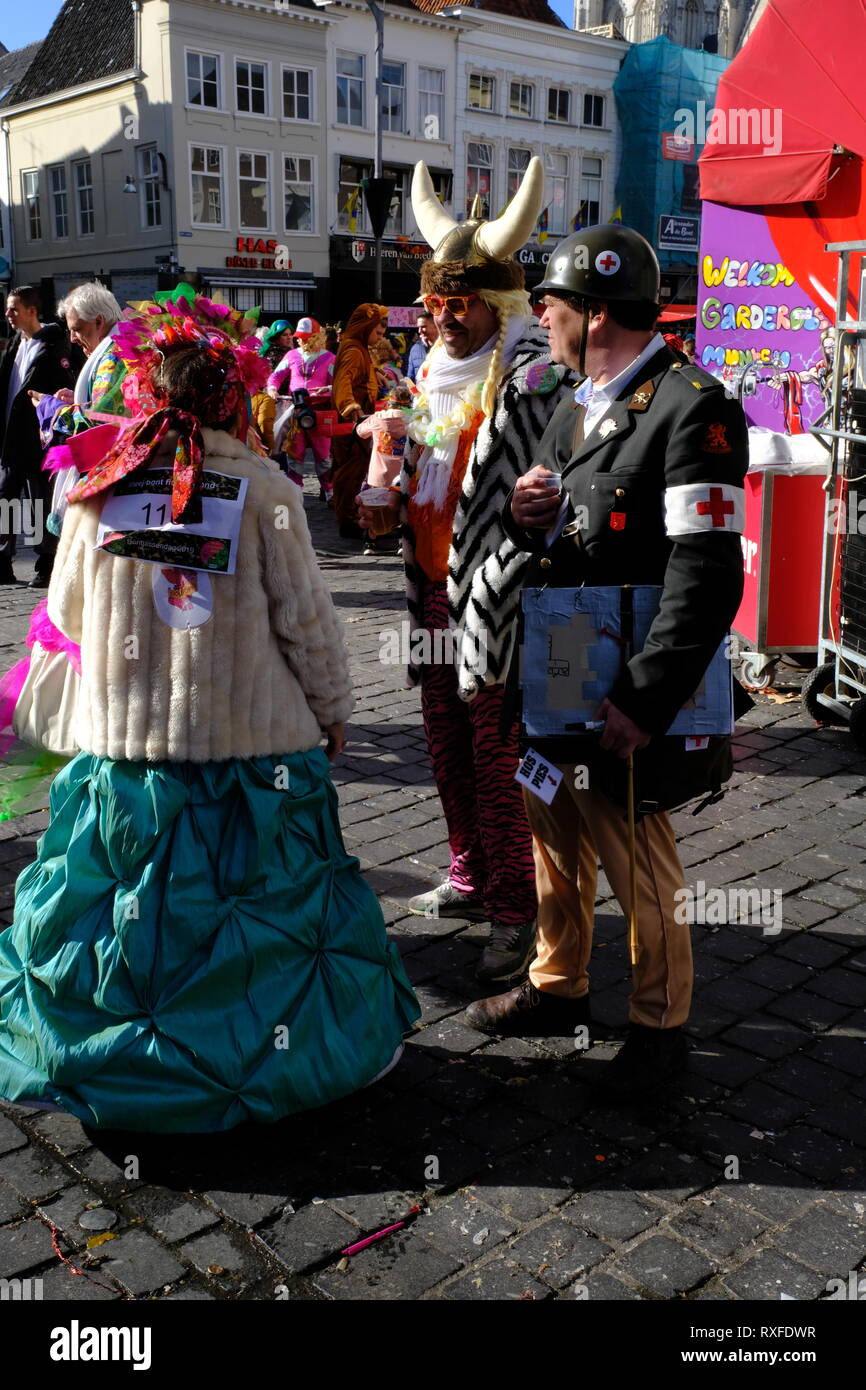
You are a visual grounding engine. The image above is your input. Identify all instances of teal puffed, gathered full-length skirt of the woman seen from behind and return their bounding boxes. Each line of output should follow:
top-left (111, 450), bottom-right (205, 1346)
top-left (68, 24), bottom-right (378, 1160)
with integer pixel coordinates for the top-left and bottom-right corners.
top-left (0, 749), bottom-right (420, 1133)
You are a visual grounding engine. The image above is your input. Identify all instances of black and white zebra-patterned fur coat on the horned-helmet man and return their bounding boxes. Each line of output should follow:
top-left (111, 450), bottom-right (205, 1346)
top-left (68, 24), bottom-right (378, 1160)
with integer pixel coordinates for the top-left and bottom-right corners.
top-left (400, 318), bottom-right (571, 701)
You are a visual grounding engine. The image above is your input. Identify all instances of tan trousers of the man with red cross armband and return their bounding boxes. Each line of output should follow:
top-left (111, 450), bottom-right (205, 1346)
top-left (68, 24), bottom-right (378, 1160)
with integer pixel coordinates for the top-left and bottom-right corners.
top-left (524, 763), bottom-right (692, 1029)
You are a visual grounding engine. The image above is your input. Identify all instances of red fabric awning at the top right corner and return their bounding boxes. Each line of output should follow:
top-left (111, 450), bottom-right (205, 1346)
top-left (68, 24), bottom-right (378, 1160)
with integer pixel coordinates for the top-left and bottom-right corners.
top-left (696, 0), bottom-right (866, 207)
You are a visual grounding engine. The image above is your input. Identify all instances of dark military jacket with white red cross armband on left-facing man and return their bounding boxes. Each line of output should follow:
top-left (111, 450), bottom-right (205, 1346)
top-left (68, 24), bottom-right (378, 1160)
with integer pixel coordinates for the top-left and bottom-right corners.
top-left (503, 348), bottom-right (748, 734)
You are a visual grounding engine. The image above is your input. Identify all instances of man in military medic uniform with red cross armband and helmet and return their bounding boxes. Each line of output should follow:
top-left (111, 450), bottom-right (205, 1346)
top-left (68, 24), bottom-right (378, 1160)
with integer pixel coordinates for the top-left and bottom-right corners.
top-left (468, 225), bottom-right (748, 1093)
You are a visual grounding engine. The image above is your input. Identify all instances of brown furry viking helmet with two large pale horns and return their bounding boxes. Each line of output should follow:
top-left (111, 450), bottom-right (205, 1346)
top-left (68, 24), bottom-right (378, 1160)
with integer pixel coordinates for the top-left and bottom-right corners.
top-left (411, 156), bottom-right (545, 295)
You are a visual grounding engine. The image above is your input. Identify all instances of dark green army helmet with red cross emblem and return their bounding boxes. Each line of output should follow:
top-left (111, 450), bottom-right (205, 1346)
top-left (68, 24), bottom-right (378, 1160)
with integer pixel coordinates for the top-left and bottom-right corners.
top-left (532, 222), bottom-right (660, 304)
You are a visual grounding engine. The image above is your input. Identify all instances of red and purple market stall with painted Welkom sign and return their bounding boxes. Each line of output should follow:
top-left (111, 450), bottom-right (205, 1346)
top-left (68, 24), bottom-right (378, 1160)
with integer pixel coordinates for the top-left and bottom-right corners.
top-left (696, 0), bottom-right (866, 687)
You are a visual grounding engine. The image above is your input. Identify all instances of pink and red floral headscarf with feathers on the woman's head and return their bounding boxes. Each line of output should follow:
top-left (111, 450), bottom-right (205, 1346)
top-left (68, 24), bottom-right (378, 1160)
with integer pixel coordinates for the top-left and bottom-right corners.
top-left (70, 285), bottom-right (268, 524)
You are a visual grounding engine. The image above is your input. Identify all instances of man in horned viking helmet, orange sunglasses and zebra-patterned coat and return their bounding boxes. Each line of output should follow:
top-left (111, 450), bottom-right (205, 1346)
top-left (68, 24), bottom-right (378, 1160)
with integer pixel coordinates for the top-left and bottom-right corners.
top-left (361, 158), bottom-right (570, 983)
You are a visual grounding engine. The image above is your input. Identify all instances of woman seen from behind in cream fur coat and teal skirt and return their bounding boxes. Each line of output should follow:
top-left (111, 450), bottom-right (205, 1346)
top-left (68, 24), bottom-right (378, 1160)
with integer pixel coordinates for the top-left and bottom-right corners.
top-left (0, 312), bottom-right (418, 1131)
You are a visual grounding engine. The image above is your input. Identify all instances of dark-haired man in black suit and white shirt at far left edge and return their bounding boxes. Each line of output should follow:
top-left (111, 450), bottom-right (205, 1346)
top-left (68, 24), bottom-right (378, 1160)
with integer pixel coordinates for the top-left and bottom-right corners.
top-left (0, 285), bottom-right (75, 588)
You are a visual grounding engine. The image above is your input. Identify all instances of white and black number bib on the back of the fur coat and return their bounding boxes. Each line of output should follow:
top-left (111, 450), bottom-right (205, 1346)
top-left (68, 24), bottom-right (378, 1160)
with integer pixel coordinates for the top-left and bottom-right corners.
top-left (96, 468), bottom-right (249, 574)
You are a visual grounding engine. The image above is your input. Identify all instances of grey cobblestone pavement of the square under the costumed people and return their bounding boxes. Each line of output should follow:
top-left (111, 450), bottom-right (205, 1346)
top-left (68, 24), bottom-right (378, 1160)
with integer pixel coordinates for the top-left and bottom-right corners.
top-left (0, 495), bottom-right (866, 1301)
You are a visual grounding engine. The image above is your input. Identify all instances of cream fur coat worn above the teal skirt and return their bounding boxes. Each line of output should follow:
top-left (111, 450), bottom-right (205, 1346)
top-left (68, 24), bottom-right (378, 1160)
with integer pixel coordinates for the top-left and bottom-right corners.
top-left (49, 430), bottom-right (353, 763)
